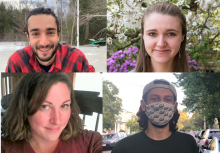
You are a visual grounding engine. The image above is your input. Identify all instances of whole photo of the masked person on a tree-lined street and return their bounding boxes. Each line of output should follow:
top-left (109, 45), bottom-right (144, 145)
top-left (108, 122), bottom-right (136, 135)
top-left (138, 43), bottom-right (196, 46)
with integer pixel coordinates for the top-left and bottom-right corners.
top-left (103, 73), bottom-right (220, 153)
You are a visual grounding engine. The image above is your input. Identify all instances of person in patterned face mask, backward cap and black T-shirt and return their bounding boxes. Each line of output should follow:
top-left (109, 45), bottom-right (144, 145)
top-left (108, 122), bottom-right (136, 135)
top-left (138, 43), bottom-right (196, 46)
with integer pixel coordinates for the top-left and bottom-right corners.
top-left (112, 79), bottom-right (198, 153)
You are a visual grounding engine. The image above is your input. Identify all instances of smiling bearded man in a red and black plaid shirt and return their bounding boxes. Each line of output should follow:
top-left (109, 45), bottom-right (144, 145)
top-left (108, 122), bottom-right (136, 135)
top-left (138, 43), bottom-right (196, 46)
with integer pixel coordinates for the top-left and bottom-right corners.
top-left (5, 7), bottom-right (95, 72)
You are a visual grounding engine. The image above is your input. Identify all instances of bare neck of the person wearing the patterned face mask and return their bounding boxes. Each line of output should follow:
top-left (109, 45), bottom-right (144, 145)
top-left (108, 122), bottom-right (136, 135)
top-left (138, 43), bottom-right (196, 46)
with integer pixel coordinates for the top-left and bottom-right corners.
top-left (145, 120), bottom-right (172, 140)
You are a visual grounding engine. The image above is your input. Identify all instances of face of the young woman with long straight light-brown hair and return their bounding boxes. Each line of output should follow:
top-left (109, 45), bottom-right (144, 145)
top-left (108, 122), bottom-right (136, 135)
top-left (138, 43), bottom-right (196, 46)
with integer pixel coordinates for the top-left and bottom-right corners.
top-left (143, 13), bottom-right (184, 65)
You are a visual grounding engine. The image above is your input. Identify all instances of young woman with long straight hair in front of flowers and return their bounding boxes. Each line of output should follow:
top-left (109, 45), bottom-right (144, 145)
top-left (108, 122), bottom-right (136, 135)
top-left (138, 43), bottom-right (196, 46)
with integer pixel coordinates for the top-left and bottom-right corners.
top-left (135, 2), bottom-right (189, 72)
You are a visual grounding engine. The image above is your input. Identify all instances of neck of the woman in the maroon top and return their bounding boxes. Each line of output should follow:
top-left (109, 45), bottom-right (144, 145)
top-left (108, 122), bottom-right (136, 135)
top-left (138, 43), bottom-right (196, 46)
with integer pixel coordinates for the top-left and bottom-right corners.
top-left (29, 138), bottom-right (59, 153)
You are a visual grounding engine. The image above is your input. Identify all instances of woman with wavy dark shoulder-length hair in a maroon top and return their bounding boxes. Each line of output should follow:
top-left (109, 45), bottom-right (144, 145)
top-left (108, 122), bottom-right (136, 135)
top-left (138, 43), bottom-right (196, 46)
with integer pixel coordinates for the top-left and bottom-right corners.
top-left (0, 73), bottom-right (102, 153)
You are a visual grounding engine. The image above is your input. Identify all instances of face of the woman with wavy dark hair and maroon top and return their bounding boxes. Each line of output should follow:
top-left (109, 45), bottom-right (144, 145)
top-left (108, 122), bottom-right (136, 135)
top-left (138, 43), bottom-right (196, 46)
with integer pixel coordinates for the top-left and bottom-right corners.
top-left (28, 82), bottom-right (71, 142)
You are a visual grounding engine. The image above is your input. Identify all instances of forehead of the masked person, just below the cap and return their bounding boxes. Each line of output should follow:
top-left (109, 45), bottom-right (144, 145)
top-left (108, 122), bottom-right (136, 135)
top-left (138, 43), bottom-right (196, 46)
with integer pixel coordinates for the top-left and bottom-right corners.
top-left (147, 88), bottom-right (174, 97)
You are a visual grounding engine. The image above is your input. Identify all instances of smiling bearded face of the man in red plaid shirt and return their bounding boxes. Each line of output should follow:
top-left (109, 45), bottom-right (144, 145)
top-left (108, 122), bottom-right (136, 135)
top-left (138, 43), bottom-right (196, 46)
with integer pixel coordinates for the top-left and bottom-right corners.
top-left (26, 14), bottom-right (59, 65)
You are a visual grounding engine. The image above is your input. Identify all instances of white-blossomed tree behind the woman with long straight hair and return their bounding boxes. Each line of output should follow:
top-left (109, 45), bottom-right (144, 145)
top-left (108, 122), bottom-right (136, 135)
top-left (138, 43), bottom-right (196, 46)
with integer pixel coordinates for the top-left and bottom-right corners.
top-left (107, 0), bottom-right (220, 70)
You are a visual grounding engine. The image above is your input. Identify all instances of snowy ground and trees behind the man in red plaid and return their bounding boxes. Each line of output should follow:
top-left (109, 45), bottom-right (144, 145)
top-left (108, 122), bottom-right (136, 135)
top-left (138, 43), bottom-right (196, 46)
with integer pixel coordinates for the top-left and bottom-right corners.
top-left (0, 0), bottom-right (107, 72)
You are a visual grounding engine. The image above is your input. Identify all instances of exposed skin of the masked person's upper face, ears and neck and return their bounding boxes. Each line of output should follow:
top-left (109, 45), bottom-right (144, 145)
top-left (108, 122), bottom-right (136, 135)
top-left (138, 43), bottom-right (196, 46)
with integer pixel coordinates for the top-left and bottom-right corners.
top-left (141, 88), bottom-right (178, 140)
